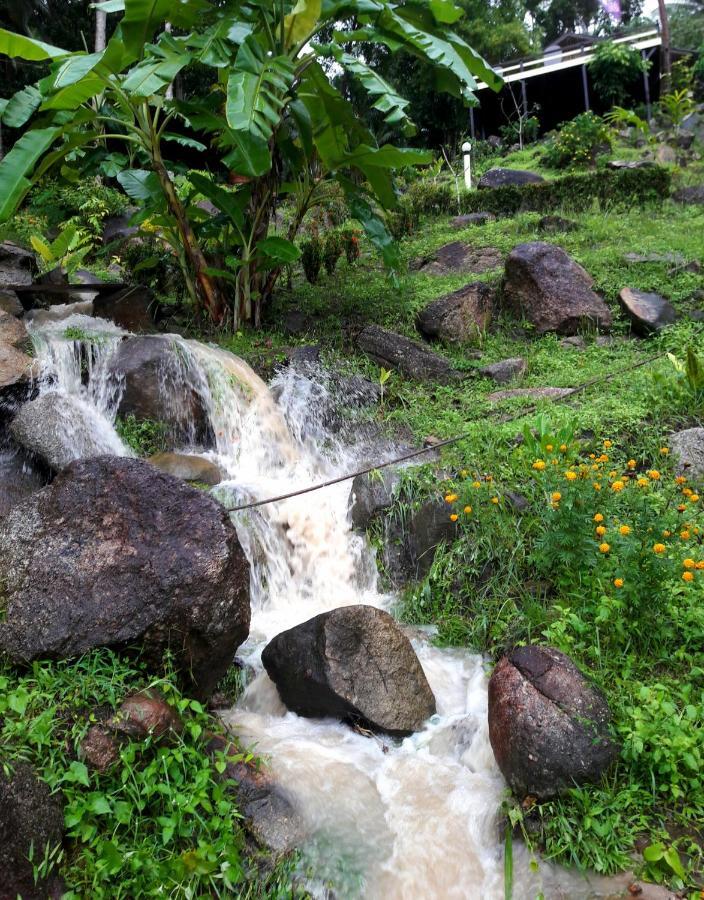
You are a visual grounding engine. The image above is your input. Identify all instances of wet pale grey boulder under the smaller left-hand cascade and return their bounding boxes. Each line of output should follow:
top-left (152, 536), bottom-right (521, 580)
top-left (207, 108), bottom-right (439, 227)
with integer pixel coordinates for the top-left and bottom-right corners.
top-left (9, 391), bottom-right (127, 472)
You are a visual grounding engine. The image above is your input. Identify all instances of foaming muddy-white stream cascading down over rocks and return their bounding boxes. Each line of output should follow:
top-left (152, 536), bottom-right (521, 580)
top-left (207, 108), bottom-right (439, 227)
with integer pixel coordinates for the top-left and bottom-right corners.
top-left (24, 316), bottom-right (628, 900)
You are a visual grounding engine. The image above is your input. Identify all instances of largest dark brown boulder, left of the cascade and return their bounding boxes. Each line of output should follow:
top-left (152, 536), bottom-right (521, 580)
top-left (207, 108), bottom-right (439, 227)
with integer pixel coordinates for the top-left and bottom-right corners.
top-left (0, 456), bottom-right (250, 696)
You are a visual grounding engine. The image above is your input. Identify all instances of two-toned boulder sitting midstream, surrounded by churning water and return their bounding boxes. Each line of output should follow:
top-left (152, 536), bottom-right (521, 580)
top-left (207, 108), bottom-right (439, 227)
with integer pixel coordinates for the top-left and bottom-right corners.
top-left (262, 606), bottom-right (435, 737)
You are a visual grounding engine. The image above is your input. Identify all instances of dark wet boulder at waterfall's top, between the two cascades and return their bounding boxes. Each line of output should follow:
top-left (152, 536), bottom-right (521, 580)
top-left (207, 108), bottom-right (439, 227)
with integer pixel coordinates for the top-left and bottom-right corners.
top-left (104, 335), bottom-right (208, 438)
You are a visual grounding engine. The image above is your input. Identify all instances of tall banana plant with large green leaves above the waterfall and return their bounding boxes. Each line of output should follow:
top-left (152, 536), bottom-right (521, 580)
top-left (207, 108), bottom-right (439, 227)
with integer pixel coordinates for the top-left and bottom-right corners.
top-left (0, 0), bottom-right (501, 328)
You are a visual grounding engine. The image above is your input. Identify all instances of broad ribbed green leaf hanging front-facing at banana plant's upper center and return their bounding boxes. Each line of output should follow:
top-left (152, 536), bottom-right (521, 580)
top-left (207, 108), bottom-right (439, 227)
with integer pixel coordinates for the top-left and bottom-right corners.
top-left (226, 37), bottom-right (293, 141)
